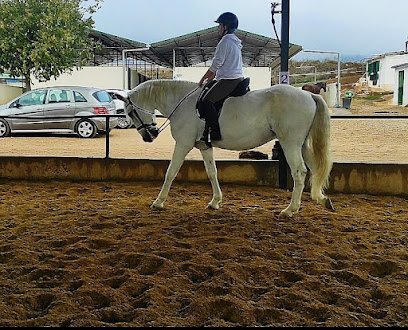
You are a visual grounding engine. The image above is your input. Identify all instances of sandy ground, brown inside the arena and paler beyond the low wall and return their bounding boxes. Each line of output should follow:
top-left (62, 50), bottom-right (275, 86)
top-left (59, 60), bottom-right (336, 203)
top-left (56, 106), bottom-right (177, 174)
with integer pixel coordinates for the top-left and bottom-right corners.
top-left (0, 96), bottom-right (408, 327)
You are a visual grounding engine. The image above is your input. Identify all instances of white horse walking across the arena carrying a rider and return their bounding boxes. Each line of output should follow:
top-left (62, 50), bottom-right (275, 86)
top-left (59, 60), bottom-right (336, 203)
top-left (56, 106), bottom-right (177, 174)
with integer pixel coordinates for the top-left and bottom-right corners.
top-left (119, 80), bottom-right (333, 217)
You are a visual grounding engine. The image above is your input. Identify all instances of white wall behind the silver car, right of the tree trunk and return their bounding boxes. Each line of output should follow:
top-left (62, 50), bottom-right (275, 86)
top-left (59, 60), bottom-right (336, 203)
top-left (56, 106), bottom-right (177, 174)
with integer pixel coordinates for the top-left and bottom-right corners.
top-left (31, 66), bottom-right (123, 89)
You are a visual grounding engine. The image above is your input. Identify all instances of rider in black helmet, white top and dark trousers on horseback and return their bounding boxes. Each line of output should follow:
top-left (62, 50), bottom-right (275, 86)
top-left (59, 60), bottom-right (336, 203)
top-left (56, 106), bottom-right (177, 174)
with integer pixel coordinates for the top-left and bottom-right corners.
top-left (198, 12), bottom-right (244, 142)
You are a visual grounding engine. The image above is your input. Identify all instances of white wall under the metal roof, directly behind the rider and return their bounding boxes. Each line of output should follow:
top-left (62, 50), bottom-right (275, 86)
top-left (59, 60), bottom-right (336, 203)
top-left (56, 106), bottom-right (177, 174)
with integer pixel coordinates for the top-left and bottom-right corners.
top-left (174, 67), bottom-right (272, 90)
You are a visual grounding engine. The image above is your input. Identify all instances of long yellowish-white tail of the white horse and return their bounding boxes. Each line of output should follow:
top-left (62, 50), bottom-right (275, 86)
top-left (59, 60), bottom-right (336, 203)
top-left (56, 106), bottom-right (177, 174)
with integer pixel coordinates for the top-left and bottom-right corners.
top-left (306, 94), bottom-right (333, 201)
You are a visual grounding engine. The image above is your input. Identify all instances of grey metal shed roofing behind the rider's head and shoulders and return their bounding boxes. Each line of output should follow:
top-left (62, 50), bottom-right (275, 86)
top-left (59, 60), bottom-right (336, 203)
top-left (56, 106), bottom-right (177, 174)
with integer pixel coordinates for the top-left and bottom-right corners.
top-left (91, 26), bottom-right (302, 68)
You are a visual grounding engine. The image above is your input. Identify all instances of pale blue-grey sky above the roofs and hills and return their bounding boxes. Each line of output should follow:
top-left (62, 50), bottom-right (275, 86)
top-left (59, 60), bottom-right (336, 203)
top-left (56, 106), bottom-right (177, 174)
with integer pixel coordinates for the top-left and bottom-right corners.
top-left (93, 0), bottom-right (408, 57)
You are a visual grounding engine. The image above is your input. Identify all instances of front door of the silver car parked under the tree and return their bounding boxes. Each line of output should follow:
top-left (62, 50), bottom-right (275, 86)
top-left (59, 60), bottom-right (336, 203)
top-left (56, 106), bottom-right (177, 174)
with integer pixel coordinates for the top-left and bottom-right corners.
top-left (10, 89), bottom-right (47, 130)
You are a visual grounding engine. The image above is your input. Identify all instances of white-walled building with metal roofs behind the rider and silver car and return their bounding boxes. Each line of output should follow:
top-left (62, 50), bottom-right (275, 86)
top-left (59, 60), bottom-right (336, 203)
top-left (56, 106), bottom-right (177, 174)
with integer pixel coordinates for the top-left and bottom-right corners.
top-left (32, 26), bottom-right (302, 89)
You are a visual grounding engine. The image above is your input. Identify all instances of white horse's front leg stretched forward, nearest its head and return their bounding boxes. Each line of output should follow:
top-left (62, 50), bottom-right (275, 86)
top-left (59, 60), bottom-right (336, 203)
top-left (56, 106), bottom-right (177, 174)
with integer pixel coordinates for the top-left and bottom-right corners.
top-left (151, 143), bottom-right (193, 209)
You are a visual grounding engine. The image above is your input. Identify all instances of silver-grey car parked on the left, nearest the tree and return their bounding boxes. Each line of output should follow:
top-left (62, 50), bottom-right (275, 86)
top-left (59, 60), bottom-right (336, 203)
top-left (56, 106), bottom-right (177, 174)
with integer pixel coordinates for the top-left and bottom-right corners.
top-left (0, 86), bottom-right (118, 138)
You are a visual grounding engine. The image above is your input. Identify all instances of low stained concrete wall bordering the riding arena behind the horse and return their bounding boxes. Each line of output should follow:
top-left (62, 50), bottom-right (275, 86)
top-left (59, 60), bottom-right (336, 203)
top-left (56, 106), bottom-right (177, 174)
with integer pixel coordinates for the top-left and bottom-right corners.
top-left (0, 157), bottom-right (408, 196)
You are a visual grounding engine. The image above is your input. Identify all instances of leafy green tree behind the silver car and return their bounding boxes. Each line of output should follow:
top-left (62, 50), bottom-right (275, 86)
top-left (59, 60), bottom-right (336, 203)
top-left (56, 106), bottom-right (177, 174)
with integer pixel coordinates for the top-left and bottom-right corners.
top-left (0, 0), bottom-right (103, 90)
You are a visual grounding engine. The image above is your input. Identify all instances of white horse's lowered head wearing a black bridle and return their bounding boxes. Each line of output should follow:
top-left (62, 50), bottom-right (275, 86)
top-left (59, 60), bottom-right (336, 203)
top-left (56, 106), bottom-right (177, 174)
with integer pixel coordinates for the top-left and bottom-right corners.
top-left (118, 85), bottom-right (159, 142)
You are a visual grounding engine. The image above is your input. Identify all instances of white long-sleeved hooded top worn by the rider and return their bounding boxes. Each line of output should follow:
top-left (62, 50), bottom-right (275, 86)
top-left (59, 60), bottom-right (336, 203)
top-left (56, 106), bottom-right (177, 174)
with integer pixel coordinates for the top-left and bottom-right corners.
top-left (210, 33), bottom-right (244, 80)
